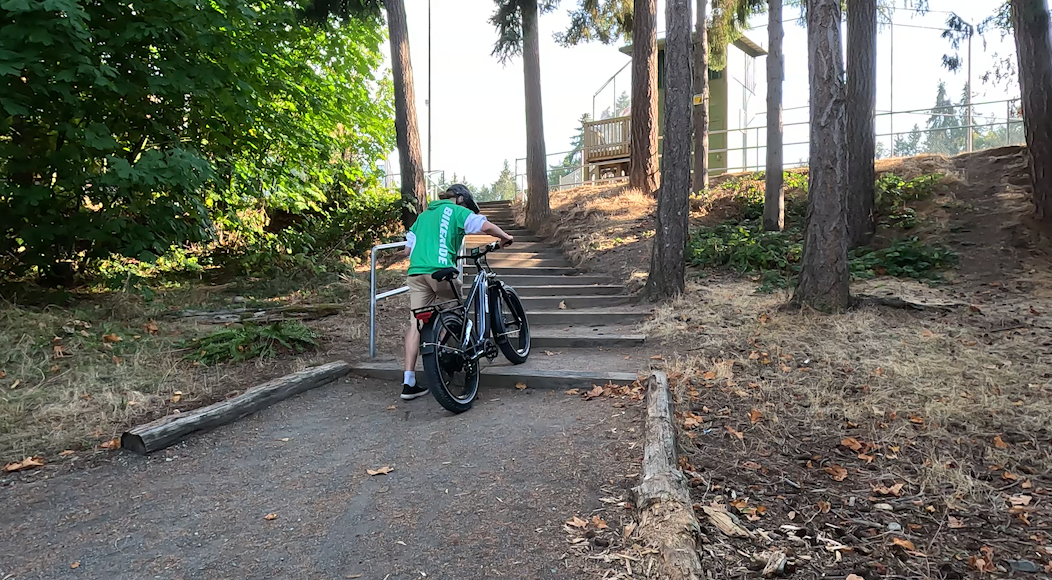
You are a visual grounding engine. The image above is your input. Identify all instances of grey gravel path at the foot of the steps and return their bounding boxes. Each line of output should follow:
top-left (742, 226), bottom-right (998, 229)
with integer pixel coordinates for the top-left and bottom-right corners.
top-left (0, 378), bottom-right (642, 580)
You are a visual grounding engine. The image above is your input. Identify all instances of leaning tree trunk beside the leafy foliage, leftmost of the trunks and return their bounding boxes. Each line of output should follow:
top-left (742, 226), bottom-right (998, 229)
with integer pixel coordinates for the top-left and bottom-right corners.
top-left (384, 0), bottom-right (427, 229)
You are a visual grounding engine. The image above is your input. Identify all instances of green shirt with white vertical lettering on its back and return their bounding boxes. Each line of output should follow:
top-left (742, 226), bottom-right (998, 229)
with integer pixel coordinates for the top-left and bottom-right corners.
top-left (409, 199), bottom-right (473, 276)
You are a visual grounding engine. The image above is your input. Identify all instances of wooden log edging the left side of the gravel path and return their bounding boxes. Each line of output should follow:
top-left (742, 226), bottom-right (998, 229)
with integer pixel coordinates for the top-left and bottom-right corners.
top-left (121, 361), bottom-right (350, 455)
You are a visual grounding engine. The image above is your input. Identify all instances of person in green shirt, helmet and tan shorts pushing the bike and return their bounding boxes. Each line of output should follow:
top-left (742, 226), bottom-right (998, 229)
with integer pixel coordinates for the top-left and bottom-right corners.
top-left (402, 183), bottom-right (514, 401)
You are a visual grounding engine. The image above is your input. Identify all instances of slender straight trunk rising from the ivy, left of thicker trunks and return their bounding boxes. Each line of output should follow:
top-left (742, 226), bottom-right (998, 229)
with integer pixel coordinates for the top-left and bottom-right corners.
top-left (764, 0), bottom-right (786, 232)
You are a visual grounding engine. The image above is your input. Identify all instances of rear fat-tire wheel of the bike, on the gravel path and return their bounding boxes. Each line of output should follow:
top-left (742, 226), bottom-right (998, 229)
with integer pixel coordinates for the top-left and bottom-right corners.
top-left (421, 313), bottom-right (479, 413)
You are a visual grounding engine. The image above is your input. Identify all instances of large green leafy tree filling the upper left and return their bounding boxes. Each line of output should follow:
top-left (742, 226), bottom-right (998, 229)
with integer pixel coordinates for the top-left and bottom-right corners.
top-left (0, 0), bottom-right (392, 282)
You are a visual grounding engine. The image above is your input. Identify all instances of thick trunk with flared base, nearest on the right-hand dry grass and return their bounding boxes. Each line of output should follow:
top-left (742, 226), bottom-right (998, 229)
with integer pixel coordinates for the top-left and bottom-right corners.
top-left (793, 0), bottom-right (851, 312)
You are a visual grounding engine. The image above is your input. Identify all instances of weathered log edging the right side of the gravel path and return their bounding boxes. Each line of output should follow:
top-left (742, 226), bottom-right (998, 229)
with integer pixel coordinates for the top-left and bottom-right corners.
top-left (632, 372), bottom-right (705, 580)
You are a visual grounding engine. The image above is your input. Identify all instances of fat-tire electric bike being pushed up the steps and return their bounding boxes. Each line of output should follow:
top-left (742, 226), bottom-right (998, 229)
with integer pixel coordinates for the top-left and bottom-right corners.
top-left (412, 242), bottom-right (529, 413)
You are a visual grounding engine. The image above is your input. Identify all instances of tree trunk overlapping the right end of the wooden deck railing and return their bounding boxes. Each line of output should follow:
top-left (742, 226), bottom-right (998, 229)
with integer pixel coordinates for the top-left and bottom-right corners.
top-left (628, 0), bottom-right (656, 195)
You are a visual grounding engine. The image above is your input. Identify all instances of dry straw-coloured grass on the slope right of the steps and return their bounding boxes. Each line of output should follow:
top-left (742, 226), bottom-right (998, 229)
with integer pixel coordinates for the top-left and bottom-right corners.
top-left (643, 281), bottom-right (1052, 501)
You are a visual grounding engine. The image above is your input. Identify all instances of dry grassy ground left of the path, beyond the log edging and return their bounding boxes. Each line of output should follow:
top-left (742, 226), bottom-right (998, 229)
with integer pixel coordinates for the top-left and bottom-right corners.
top-left (0, 280), bottom-right (391, 464)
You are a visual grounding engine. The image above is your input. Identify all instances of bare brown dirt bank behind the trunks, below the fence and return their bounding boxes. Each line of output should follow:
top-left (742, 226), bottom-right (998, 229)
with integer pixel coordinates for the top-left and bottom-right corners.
top-left (545, 146), bottom-right (1052, 287)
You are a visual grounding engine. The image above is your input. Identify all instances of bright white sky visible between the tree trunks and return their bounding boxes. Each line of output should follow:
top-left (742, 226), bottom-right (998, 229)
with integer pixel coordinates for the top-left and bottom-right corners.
top-left (385, 0), bottom-right (1019, 185)
